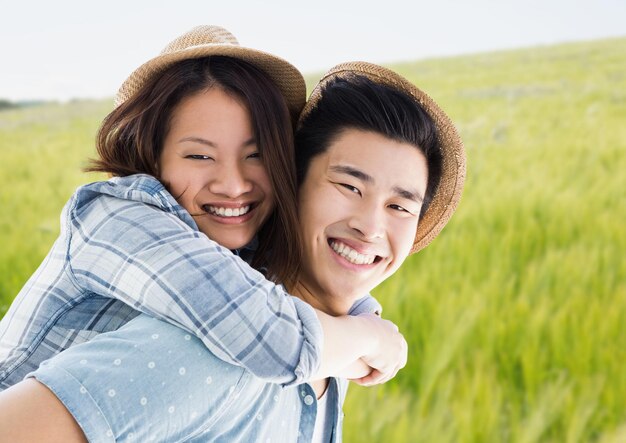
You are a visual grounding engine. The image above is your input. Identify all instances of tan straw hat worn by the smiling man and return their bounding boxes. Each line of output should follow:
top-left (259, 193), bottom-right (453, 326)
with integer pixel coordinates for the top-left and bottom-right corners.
top-left (299, 62), bottom-right (465, 254)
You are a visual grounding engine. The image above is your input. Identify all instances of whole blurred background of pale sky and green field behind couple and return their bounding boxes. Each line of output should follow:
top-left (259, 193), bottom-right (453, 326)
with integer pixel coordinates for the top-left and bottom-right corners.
top-left (0, 0), bottom-right (626, 443)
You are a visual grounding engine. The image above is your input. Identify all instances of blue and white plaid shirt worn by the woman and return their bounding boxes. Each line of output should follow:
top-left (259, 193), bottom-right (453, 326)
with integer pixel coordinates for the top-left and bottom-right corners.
top-left (0, 175), bottom-right (322, 390)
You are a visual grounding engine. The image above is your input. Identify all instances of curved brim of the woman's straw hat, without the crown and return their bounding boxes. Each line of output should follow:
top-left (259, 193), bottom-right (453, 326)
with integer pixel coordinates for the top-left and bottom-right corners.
top-left (115, 43), bottom-right (306, 119)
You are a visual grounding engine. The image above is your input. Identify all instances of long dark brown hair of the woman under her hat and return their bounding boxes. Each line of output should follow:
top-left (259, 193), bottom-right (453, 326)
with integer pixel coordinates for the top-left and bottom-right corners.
top-left (86, 56), bottom-right (301, 285)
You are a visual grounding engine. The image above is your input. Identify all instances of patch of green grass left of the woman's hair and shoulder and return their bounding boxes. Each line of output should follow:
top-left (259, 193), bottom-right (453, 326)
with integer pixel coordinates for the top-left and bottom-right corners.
top-left (0, 102), bottom-right (111, 306)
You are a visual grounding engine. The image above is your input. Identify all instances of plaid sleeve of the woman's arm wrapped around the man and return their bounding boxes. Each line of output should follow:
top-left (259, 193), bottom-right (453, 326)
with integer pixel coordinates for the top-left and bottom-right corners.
top-left (65, 196), bottom-right (323, 385)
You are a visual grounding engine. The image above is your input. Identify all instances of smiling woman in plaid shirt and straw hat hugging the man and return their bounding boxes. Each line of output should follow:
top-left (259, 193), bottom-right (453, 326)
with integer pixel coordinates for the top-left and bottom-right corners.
top-left (0, 26), bottom-right (405, 388)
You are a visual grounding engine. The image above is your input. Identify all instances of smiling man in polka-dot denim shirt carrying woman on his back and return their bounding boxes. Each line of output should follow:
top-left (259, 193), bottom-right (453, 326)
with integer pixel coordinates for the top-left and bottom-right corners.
top-left (0, 63), bottom-right (465, 442)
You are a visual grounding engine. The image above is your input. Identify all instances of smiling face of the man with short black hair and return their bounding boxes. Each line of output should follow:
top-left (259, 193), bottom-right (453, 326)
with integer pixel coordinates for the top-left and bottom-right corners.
top-left (299, 129), bottom-right (428, 314)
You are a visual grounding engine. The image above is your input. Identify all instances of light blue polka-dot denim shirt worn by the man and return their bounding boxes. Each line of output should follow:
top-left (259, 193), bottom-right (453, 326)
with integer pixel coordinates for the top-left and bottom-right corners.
top-left (30, 306), bottom-right (377, 443)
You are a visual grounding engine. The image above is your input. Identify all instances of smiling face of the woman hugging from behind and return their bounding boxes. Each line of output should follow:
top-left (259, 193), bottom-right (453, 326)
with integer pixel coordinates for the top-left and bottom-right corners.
top-left (159, 87), bottom-right (274, 249)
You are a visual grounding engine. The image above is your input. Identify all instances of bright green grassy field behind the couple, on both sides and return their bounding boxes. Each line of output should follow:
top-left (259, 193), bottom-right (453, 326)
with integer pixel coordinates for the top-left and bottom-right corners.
top-left (0, 38), bottom-right (626, 443)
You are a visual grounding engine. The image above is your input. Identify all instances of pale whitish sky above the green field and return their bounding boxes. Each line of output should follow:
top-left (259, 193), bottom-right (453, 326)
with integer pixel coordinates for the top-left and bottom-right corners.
top-left (0, 0), bottom-right (626, 101)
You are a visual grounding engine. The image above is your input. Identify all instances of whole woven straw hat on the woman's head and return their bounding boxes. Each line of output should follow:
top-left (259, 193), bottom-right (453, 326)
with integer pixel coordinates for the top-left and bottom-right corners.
top-left (115, 25), bottom-right (306, 116)
